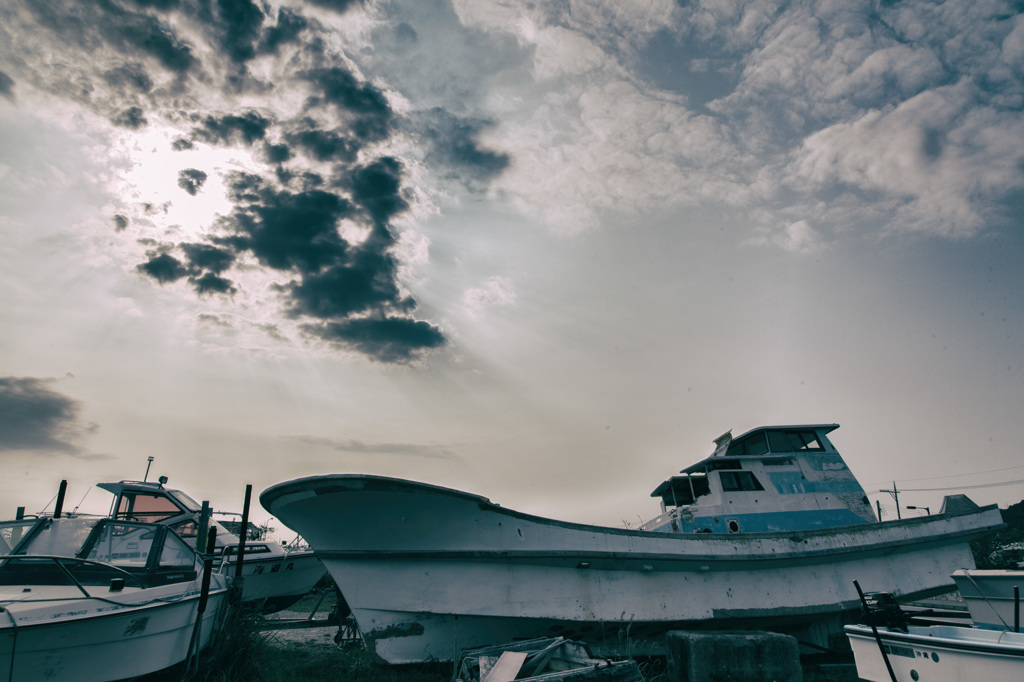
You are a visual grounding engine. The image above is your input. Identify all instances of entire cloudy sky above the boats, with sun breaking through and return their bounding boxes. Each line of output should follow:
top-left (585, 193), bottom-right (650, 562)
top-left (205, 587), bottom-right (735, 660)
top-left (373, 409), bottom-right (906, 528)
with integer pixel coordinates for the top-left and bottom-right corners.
top-left (0, 0), bottom-right (1024, 535)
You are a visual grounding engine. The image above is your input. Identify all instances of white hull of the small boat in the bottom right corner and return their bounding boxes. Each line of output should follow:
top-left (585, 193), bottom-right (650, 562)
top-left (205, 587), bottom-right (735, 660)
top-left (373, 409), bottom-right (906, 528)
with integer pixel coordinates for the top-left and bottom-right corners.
top-left (846, 626), bottom-right (1024, 682)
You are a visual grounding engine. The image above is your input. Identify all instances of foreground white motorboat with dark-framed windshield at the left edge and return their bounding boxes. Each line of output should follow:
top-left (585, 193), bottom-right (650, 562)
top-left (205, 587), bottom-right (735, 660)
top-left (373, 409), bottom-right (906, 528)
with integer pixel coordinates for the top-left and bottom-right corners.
top-left (0, 517), bottom-right (228, 682)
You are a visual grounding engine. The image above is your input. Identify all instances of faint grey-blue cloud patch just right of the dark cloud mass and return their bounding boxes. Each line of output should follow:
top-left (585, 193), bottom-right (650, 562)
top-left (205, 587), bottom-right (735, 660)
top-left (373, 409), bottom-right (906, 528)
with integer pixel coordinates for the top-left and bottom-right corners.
top-left (413, 109), bottom-right (510, 189)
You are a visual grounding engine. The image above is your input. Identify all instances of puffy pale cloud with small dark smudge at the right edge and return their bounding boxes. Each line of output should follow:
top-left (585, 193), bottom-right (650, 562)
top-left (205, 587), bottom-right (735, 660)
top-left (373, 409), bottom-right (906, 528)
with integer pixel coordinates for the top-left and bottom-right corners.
top-left (788, 81), bottom-right (1024, 238)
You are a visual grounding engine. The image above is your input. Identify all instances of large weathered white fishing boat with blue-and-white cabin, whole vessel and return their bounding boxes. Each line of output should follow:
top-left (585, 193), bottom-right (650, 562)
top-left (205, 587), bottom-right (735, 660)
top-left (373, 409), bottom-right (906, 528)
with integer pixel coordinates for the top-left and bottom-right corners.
top-left (260, 424), bottom-right (1002, 664)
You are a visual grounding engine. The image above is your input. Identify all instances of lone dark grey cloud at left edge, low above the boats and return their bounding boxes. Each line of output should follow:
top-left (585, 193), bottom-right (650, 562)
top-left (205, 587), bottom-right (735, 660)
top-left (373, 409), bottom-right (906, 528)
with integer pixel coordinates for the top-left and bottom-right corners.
top-left (0, 377), bottom-right (95, 454)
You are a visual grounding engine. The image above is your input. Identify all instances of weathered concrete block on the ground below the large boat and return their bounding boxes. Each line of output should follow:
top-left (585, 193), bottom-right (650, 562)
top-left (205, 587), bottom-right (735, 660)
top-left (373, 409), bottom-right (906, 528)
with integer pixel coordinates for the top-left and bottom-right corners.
top-left (665, 630), bottom-right (804, 682)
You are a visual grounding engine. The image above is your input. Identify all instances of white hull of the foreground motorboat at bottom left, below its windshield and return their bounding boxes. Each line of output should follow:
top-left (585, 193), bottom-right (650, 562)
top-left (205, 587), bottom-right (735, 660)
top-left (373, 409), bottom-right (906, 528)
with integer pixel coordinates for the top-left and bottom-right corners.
top-left (0, 577), bottom-right (226, 682)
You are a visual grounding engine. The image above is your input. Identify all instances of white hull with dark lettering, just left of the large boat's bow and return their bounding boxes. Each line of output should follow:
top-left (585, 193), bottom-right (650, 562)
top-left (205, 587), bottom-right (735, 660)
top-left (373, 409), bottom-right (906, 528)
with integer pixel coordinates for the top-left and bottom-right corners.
top-left (221, 551), bottom-right (327, 613)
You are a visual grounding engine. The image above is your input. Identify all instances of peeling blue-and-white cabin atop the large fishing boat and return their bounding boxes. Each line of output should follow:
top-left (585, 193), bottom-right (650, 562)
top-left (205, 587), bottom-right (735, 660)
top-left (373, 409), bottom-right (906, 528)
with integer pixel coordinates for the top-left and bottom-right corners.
top-left (642, 424), bottom-right (877, 532)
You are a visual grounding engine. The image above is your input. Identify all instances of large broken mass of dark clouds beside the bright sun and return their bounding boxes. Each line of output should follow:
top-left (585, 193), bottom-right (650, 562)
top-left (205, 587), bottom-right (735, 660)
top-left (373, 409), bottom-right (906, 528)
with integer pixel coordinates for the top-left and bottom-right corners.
top-left (7, 0), bottom-right (448, 363)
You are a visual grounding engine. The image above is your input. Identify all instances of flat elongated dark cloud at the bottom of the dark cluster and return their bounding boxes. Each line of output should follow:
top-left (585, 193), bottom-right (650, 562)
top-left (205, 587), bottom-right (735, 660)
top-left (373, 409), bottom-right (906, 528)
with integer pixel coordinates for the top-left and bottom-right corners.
top-left (305, 317), bottom-right (445, 365)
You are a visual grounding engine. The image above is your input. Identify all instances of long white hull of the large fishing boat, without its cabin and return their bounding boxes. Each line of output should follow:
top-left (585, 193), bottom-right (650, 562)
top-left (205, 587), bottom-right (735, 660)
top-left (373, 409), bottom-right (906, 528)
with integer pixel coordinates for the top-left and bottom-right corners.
top-left (261, 475), bottom-right (1001, 664)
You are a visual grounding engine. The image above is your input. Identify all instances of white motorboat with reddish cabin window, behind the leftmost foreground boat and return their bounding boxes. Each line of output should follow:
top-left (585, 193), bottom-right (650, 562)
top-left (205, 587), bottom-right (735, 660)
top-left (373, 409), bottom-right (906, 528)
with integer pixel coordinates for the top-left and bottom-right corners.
top-left (98, 476), bottom-right (327, 613)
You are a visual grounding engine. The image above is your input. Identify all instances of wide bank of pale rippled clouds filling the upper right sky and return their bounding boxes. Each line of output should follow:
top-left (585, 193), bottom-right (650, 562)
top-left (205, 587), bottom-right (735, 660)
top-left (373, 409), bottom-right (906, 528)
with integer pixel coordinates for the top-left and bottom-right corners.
top-left (448, 0), bottom-right (1024, 241)
